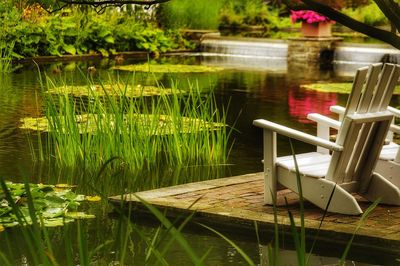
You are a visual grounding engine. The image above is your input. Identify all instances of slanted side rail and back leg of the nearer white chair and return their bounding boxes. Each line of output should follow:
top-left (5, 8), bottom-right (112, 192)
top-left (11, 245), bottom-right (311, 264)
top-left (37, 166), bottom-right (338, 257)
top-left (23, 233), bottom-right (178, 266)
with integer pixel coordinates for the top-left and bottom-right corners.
top-left (277, 168), bottom-right (362, 215)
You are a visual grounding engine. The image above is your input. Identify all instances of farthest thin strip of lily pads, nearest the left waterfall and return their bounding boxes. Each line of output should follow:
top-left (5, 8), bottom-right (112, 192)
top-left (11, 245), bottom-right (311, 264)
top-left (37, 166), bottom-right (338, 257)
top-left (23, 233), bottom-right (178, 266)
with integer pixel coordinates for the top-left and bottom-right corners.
top-left (113, 63), bottom-right (223, 73)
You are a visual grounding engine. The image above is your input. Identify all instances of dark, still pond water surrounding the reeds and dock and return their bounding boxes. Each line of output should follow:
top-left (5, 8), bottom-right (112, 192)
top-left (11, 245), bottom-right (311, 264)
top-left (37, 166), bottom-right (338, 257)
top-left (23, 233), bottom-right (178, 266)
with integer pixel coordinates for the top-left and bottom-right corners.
top-left (0, 55), bottom-right (399, 265)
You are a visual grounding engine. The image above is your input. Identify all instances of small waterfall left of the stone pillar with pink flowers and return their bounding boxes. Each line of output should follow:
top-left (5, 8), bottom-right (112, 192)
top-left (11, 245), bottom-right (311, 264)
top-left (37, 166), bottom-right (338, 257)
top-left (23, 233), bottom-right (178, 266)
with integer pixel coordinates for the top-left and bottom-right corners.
top-left (201, 39), bottom-right (288, 72)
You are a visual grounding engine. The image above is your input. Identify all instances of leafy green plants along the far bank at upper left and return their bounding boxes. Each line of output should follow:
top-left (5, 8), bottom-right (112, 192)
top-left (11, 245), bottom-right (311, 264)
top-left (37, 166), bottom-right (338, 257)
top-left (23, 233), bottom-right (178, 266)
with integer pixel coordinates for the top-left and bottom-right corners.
top-left (0, 4), bottom-right (190, 58)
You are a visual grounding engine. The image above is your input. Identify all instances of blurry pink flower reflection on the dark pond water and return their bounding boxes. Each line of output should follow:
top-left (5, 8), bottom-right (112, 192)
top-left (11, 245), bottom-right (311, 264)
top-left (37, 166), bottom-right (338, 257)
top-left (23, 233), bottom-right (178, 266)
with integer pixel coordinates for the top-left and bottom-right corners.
top-left (288, 90), bottom-right (337, 124)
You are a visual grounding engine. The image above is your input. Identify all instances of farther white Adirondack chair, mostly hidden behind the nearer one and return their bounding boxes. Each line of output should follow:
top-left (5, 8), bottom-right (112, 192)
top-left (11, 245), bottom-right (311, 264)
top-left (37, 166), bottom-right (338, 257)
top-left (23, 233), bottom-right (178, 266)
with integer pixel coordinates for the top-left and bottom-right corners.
top-left (307, 65), bottom-right (400, 188)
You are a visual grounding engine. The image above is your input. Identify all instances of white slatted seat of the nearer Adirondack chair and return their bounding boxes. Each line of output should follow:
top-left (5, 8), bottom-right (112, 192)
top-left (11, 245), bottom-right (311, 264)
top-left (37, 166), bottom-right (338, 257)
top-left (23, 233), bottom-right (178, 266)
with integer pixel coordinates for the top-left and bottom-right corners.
top-left (276, 152), bottom-right (331, 178)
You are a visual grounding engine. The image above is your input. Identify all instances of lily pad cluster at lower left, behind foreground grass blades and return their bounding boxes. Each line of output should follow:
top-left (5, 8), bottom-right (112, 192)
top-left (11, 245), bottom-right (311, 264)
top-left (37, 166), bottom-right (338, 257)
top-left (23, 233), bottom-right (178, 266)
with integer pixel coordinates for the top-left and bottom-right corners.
top-left (0, 182), bottom-right (99, 232)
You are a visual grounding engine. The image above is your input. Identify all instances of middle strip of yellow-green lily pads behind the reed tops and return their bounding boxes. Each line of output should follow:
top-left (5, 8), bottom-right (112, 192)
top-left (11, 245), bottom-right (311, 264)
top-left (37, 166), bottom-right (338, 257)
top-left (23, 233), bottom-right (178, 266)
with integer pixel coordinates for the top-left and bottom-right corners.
top-left (47, 84), bottom-right (183, 98)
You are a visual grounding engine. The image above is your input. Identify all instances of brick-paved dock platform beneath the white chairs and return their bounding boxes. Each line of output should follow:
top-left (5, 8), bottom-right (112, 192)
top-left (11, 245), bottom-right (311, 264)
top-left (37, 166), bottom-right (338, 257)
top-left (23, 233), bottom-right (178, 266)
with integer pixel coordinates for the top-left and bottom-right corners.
top-left (109, 173), bottom-right (400, 254)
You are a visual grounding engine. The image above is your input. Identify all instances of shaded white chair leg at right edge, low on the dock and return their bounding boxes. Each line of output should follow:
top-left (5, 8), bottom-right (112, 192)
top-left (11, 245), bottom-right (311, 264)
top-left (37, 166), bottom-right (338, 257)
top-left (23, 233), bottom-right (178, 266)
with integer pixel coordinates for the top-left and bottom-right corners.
top-left (362, 173), bottom-right (400, 206)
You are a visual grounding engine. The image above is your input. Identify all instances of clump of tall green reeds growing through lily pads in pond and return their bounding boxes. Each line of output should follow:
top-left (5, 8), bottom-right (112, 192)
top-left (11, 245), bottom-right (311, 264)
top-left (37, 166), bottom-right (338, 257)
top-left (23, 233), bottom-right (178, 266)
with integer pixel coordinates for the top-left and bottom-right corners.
top-left (31, 78), bottom-right (229, 171)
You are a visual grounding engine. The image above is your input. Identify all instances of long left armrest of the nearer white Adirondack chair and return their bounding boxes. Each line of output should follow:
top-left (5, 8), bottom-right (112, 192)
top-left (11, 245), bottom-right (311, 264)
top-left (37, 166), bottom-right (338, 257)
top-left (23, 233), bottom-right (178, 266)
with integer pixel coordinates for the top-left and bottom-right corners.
top-left (253, 119), bottom-right (343, 151)
